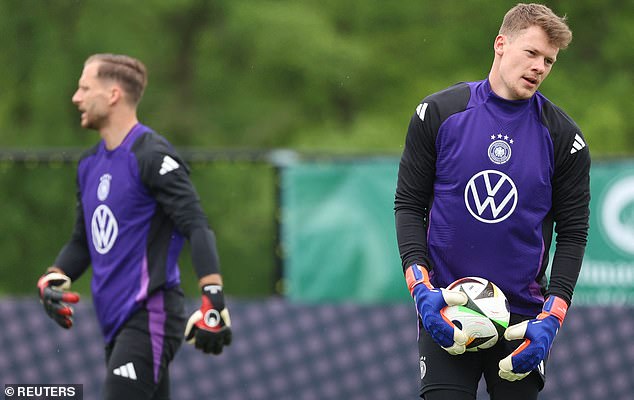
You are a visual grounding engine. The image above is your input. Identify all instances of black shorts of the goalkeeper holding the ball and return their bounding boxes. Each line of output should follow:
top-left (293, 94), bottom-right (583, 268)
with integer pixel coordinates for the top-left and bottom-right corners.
top-left (418, 314), bottom-right (546, 400)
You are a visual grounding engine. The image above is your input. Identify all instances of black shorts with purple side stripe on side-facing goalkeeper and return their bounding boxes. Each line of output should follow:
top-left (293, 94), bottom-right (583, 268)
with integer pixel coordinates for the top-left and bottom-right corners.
top-left (104, 288), bottom-right (185, 400)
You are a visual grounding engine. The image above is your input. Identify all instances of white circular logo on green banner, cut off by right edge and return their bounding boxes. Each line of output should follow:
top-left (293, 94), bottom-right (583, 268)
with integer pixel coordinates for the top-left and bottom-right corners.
top-left (601, 176), bottom-right (634, 254)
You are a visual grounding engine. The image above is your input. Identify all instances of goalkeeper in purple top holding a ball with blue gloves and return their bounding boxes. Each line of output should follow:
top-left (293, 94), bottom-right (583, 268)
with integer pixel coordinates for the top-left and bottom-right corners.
top-left (395, 4), bottom-right (590, 400)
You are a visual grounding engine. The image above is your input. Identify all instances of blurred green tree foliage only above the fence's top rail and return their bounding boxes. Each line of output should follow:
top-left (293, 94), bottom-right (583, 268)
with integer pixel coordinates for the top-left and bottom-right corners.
top-left (0, 0), bottom-right (634, 155)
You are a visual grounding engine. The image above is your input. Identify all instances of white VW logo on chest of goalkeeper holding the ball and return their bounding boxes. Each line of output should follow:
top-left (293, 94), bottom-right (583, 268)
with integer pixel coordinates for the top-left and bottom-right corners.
top-left (464, 169), bottom-right (517, 224)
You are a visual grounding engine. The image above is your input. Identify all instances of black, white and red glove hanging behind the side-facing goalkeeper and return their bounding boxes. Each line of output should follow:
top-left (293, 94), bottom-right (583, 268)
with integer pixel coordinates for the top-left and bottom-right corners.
top-left (185, 285), bottom-right (231, 354)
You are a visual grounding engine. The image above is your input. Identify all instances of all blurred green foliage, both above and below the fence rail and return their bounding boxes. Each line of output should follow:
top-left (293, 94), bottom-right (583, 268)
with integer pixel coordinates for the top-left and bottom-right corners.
top-left (0, 0), bottom-right (634, 298)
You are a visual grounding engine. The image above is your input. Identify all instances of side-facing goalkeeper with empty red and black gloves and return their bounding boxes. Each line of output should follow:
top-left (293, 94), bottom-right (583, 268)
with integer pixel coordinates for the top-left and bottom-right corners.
top-left (37, 54), bottom-right (231, 400)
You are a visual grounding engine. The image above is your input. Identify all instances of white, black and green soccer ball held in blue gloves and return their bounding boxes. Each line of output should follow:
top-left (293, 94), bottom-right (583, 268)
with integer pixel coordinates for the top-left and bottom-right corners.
top-left (440, 276), bottom-right (511, 351)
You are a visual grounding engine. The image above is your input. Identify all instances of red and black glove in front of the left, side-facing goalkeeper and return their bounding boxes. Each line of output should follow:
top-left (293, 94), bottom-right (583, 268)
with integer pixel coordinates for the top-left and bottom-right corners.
top-left (37, 272), bottom-right (79, 329)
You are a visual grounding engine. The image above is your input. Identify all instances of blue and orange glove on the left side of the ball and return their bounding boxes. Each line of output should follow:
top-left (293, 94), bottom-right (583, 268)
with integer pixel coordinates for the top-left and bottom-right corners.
top-left (405, 264), bottom-right (468, 355)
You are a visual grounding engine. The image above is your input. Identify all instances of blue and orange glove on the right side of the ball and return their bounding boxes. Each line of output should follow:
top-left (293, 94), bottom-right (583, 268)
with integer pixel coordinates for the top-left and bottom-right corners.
top-left (498, 296), bottom-right (568, 381)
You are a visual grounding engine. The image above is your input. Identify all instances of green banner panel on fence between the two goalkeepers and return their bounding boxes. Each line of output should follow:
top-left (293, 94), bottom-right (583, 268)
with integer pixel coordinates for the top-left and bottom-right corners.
top-left (281, 159), bottom-right (409, 302)
